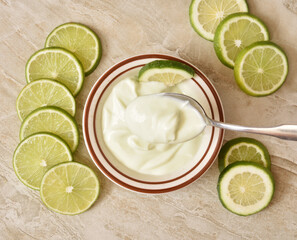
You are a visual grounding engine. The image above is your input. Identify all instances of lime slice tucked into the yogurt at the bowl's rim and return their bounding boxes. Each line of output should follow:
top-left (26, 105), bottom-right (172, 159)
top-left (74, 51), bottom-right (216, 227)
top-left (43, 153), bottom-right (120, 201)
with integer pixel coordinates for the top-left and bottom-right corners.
top-left (138, 60), bottom-right (195, 86)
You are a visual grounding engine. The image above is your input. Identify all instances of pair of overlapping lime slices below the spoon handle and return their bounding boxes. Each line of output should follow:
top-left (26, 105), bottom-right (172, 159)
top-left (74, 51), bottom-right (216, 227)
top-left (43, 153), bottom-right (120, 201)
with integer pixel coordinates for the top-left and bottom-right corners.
top-left (217, 137), bottom-right (274, 216)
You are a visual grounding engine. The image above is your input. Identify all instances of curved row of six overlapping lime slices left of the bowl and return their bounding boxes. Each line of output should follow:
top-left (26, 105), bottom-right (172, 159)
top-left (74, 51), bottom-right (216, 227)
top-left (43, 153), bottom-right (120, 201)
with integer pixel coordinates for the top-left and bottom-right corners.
top-left (13, 23), bottom-right (102, 215)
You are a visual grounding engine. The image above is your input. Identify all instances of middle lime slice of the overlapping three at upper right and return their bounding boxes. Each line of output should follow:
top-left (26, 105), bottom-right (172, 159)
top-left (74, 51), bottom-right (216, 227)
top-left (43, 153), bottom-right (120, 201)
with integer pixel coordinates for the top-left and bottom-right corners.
top-left (214, 13), bottom-right (269, 68)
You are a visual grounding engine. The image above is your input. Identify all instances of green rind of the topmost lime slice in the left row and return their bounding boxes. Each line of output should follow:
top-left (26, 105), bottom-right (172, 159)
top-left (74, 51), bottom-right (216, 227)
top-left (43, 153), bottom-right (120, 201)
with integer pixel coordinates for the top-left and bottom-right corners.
top-left (44, 22), bottom-right (102, 76)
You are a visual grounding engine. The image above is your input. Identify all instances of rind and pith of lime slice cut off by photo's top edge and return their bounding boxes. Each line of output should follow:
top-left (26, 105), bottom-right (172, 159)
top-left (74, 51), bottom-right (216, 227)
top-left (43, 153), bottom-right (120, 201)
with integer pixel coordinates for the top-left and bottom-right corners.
top-left (189, 0), bottom-right (249, 42)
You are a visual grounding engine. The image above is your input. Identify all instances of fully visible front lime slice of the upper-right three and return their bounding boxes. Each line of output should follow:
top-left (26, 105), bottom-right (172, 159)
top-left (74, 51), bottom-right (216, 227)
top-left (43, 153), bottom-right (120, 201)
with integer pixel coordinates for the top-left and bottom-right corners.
top-left (234, 42), bottom-right (289, 97)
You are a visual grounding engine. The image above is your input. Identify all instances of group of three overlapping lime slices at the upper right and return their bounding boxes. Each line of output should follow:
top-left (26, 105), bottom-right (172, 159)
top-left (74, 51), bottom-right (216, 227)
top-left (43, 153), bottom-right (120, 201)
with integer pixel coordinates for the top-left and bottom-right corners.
top-left (189, 0), bottom-right (288, 96)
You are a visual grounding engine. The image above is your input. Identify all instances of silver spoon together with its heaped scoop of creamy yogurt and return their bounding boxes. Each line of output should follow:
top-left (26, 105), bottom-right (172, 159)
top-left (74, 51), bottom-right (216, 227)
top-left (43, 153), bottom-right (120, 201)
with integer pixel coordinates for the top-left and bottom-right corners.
top-left (125, 93), bottom-right (297, 144)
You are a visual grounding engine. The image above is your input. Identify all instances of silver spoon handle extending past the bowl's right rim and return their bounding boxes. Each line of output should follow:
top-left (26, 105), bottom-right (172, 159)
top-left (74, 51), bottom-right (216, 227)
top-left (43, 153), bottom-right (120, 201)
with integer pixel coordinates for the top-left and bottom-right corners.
top-left (210, 120), bottom-right (297, 141)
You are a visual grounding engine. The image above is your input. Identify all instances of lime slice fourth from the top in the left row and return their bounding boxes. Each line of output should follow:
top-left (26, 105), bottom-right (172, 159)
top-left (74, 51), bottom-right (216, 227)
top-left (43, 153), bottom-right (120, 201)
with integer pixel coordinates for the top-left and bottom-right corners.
top-left (20, 107), bottom-right (79, 152)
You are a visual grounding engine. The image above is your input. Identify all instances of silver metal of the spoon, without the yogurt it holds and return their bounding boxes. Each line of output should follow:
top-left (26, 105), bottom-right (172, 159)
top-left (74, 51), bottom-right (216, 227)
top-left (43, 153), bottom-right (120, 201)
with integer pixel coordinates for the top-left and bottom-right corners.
top-left (161, 93), bottom-right (297, 141)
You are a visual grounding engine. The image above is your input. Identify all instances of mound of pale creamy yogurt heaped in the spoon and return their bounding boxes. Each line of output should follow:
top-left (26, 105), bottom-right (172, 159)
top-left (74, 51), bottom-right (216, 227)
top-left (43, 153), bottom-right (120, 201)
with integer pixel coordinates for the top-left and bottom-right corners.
top-left (125, 94), bottom-right (206, 143)
